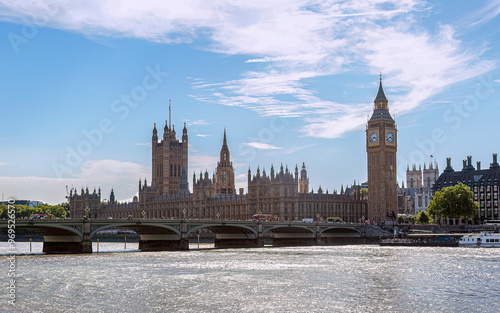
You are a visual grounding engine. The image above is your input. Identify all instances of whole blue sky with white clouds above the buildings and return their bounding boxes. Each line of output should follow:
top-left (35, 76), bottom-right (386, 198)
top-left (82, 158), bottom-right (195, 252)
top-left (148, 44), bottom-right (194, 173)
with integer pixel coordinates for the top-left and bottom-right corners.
top-left (0, 0), bottom-right (500, 204)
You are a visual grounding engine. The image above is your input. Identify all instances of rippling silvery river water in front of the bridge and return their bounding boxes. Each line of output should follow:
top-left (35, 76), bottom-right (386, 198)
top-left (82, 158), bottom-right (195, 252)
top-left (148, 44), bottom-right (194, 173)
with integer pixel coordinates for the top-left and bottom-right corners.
top-left (0, 243), bottom-right (500, 312)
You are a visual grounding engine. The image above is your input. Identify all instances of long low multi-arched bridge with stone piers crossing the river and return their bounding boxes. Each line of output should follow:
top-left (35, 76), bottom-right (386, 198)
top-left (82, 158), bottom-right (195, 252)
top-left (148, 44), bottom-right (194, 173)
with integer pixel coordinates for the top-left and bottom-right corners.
top-left (0, 218), bottom-right (388, 253)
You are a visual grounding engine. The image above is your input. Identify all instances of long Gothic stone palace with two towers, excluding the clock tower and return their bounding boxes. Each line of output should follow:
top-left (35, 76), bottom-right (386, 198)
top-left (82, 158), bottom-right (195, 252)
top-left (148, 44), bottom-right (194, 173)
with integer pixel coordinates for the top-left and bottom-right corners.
top-left (69, 106), bottom-right (367, 222)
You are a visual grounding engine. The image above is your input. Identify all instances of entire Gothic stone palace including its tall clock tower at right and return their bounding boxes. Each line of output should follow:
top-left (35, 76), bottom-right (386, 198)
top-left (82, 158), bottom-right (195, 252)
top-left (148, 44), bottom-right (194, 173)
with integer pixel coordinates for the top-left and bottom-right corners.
top-left (69, 79), bottom-right (398, 222)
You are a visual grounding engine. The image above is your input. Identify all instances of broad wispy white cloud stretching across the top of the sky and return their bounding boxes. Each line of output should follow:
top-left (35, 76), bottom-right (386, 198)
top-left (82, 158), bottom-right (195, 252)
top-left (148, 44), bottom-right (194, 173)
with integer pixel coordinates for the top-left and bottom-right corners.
top-left (0, 0), bottom-right (500, 138)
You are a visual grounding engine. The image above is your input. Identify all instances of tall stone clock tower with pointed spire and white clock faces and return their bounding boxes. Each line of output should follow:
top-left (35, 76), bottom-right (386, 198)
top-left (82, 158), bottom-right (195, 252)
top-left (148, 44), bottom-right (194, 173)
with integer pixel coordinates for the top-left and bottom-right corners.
top-left (366, 75), bottom-right (398, 222)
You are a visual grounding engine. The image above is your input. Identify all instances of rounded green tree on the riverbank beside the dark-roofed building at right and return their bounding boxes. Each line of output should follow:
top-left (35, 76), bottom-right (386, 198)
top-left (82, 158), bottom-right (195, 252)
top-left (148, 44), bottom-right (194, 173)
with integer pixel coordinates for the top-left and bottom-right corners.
top-left (429, 183), bottom-right (479, 218)
